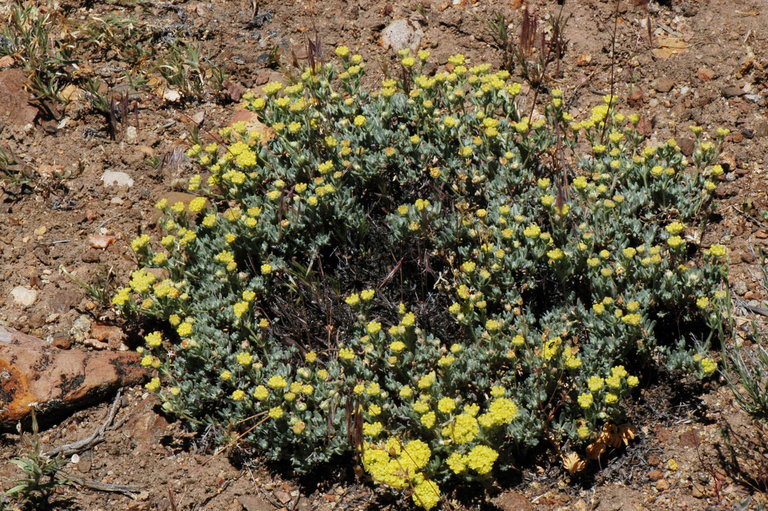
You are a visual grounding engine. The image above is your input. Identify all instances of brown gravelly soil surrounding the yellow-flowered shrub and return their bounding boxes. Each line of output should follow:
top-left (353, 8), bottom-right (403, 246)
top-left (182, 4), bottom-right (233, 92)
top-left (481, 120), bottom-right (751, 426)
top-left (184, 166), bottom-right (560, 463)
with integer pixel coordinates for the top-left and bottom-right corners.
top-left (0, 0), bottom-right (768, 511)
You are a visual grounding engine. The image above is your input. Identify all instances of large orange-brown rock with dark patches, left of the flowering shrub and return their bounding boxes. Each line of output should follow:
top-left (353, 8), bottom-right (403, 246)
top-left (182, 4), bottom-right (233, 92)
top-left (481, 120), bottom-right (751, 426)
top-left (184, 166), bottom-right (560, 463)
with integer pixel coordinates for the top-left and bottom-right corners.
top-left (0, 326), bottom-right (146, 428)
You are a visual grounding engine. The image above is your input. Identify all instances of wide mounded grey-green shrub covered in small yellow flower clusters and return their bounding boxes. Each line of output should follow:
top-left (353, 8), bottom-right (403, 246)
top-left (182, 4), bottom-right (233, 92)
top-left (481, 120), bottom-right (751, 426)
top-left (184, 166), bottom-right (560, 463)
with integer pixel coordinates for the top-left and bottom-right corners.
top-left (113, 47), bottom-right (727, 509)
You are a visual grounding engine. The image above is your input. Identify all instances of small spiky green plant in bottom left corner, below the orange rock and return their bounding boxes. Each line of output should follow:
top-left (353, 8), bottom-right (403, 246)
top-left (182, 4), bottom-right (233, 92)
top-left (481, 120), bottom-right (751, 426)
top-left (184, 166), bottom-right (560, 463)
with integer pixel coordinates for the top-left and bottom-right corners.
top-left (5, 410), bottom-right (66, 510)
